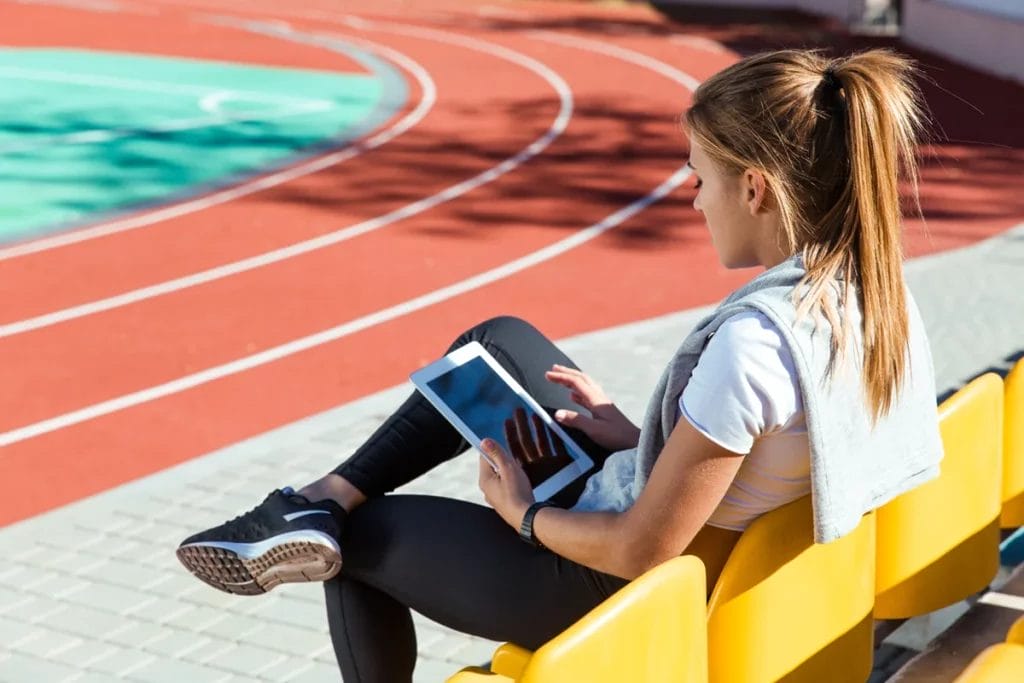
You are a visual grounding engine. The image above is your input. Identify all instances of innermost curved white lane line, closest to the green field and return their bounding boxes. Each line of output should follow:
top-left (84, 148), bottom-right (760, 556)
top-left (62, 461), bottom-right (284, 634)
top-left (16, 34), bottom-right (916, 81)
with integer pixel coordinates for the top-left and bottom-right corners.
top-left (0, 30), bottom-right (437, 261)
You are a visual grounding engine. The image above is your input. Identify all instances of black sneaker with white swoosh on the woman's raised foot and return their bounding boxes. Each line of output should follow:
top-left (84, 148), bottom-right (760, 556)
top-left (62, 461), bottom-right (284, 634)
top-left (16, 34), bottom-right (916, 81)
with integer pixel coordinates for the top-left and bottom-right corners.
top-left (177, 487), bottom-right (345, 595)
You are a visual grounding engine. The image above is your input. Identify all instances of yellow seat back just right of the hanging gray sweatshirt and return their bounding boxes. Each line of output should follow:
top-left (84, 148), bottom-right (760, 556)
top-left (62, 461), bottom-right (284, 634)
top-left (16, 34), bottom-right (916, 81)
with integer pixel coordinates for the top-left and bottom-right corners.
top-left (874, 373), bottom-right (1004, 618)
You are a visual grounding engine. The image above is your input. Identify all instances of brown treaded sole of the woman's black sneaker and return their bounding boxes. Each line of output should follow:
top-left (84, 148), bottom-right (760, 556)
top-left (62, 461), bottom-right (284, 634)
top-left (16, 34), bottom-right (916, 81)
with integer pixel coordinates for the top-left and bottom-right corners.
top-left (177, 541), bottom-right (341, 595)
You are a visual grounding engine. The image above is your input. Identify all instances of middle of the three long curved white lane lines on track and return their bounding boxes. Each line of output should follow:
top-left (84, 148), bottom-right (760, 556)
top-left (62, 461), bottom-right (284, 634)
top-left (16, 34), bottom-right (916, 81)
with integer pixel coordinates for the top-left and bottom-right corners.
top-left (0, 20), bottom-right (572, 338)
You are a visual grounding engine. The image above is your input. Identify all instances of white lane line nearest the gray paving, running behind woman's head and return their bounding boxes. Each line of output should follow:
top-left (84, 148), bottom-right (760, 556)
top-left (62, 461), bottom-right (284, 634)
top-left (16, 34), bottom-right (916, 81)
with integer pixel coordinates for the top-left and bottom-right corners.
top-left (0, 29), bottom-right (697, 446)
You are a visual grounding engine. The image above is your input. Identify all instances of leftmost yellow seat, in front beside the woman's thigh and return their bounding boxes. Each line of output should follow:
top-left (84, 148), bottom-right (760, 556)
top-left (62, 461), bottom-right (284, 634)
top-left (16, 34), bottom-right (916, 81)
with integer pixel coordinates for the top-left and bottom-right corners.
top-left (447, 555), bottom-right (708, 683)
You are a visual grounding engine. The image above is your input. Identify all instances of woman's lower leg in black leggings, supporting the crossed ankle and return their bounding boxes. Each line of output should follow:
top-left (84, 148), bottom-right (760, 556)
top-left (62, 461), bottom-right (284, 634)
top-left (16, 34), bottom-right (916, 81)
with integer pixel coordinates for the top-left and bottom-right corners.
top-left (325, 496), bottom-right (628, 683)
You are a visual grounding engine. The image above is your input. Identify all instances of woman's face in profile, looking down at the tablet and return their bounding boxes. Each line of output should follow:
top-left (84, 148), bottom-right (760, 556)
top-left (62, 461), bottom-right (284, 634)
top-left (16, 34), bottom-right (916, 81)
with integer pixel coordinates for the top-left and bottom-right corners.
top-left (689, 139), bottom-right (761, 268)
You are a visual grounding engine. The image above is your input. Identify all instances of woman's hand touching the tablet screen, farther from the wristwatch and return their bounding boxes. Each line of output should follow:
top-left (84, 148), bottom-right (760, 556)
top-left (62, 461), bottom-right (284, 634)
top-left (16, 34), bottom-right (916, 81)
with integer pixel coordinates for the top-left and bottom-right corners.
top-left (545, 365), bottom-right (640, 451)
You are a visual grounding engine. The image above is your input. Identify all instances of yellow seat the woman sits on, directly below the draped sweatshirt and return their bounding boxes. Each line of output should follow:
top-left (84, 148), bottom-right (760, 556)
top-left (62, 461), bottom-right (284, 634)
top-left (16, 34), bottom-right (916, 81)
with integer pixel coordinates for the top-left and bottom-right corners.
top-left (708, 496), bottom-right (876, 683)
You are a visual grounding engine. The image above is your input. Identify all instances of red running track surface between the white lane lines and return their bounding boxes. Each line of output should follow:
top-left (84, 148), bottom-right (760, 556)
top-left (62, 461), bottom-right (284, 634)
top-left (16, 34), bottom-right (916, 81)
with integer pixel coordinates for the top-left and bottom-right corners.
top-left (0, 0), bottom-right (1024, 523)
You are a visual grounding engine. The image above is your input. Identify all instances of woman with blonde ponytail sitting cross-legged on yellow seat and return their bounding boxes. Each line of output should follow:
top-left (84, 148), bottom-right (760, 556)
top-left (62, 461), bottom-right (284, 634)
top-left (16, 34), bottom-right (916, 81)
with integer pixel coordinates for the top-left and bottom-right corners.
top-left (178, 45), bottom-right (941, 683)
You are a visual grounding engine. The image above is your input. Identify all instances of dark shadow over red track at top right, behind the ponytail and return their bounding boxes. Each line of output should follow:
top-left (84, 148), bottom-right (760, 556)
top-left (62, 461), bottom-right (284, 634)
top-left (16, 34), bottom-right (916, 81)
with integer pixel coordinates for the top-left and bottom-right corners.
top-left (464, 2), bottom-right (1024, 239)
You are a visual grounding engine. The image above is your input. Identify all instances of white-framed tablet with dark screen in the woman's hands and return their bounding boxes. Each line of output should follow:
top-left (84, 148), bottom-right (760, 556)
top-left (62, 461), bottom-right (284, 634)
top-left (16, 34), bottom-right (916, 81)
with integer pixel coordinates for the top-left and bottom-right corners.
top-left (410, 342), bottom-right (594, 501)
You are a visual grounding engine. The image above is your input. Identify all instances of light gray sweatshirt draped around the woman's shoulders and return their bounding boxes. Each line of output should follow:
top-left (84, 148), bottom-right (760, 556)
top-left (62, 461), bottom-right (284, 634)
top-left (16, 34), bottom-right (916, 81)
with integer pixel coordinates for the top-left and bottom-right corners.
top-left (572, 254), bottom-right (942, 543)
